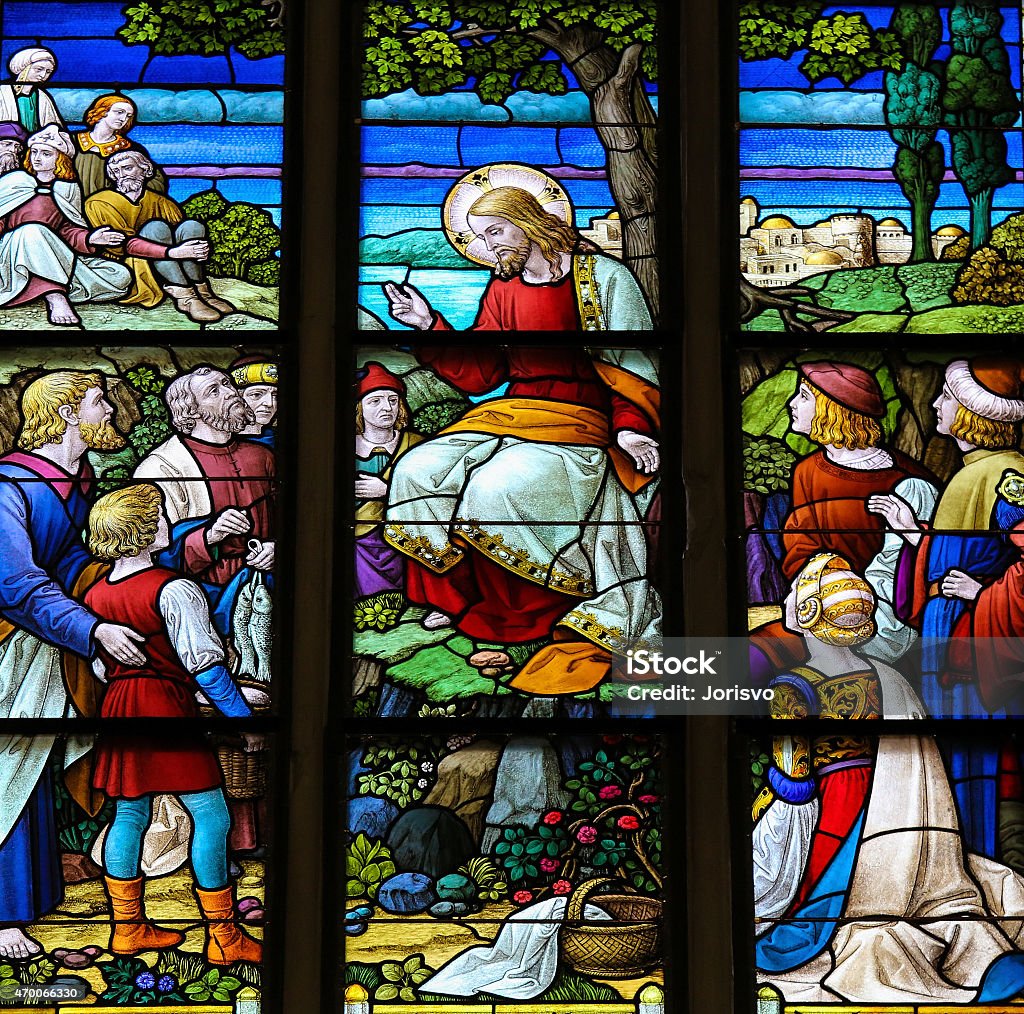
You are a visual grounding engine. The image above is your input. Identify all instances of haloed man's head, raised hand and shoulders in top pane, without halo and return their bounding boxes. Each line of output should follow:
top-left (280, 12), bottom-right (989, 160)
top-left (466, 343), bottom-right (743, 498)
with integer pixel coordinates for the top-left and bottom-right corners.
top-left (384, 186), bottom-right (652, 331)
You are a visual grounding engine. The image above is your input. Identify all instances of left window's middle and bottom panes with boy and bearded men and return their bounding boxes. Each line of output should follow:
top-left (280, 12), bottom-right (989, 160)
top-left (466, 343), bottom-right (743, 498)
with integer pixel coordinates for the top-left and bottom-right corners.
top-left (0, 345), bottom-right (287, 1005)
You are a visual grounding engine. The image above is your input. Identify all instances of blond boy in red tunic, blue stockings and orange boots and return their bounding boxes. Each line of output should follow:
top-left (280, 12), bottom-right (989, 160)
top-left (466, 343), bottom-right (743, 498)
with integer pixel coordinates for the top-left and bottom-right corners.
top-left (85, 483), bottom-right (262, 965)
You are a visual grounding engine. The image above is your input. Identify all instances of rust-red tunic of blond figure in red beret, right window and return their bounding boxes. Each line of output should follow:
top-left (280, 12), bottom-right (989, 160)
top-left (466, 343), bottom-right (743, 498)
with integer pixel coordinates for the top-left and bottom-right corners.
top-left (782, 451), bottom-right (938, 581)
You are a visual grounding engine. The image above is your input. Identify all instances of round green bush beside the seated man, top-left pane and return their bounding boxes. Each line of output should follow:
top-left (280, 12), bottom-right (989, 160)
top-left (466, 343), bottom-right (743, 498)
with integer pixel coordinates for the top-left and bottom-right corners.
top-left (182, 191), bottom-right (281, 285)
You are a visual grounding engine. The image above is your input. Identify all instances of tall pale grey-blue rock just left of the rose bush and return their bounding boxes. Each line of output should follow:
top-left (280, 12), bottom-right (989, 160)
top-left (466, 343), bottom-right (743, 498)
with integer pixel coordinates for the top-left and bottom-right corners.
top-left (481, 736), bottom-right (569, 854)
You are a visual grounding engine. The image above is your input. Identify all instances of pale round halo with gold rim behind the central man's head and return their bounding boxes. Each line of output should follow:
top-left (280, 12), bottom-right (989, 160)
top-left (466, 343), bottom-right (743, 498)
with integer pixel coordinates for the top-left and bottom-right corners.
top-left (441, 162), bottom-right (572, 267)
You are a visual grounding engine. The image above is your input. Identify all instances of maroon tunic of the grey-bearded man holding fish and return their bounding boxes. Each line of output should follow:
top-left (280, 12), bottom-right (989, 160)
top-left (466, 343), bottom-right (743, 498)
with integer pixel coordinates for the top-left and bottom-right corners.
top-left (182, 436), bottom-right (274, 585)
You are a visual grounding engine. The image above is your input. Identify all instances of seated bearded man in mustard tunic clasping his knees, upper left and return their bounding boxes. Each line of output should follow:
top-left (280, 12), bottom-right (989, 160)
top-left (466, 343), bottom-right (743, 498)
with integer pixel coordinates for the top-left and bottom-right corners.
top-left (85, 152), bottom-right (234, 324)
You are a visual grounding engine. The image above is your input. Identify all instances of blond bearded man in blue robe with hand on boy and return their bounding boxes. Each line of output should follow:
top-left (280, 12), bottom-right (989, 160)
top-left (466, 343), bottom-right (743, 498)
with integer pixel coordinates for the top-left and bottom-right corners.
top-left (0, 371), bottom-right (145, 960)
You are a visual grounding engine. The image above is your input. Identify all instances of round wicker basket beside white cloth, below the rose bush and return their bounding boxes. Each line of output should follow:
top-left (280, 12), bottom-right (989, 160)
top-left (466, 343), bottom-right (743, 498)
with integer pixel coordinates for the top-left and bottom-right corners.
top-left (561, 877), bottom-right (662, 979)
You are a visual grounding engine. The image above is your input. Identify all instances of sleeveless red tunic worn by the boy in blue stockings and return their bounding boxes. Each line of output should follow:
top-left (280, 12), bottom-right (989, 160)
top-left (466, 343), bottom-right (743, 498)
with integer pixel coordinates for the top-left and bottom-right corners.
top-left (85, 567), bottom-right (221, 799)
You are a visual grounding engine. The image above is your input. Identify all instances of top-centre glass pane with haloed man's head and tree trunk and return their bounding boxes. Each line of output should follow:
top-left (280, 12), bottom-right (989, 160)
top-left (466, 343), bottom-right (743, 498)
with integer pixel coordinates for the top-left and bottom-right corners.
top-left (358, 0), bottom-right (659, 331)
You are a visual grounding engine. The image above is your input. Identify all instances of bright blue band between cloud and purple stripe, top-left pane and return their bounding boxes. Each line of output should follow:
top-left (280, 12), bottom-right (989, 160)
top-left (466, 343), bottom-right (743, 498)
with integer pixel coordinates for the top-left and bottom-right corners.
top-left (131, 124), bottom-right (284, 166)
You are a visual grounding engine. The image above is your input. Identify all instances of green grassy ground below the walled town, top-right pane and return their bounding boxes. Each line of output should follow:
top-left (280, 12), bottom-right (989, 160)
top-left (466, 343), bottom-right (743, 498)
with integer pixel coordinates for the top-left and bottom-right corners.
top-left (744, 261), bottom-right (1024, 334)
